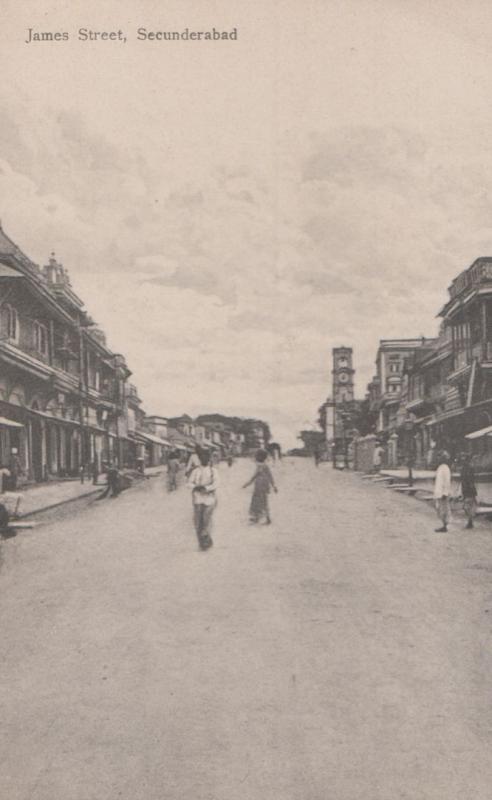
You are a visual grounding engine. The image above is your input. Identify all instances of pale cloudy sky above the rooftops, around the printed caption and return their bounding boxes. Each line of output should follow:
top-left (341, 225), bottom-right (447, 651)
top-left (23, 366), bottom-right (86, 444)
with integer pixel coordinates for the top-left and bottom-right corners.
top-left (0, 0), bottom-right (492, 445)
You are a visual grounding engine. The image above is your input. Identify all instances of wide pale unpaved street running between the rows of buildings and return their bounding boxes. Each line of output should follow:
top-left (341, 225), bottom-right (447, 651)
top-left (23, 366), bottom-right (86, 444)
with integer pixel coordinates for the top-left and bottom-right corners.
top-left (0, 459), bottom-right (492, 800)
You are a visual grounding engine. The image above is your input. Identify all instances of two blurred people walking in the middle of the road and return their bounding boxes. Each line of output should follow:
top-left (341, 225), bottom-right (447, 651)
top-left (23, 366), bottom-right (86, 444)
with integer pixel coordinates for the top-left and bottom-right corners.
top-left (185, 447), bottom-right (277, 550)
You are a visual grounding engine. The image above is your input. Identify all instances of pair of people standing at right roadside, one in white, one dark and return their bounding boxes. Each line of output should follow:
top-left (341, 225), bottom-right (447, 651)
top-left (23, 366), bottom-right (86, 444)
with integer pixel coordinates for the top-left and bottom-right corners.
top-left (434, 450), bottom-right (478, 533)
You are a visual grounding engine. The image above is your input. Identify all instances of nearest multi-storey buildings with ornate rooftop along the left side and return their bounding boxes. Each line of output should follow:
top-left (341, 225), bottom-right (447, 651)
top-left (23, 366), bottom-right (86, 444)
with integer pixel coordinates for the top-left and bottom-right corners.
top-left (0, 228), bottom-right (131, 481)
